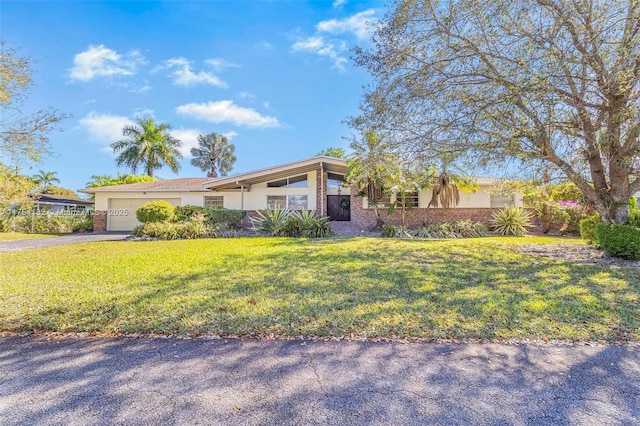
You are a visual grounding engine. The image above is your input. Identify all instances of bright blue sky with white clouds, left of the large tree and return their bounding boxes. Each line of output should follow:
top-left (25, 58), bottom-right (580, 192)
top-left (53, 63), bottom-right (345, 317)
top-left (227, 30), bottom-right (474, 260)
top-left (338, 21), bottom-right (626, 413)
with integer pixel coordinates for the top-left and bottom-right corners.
top-left (0, 0), bottom-right (384, 190)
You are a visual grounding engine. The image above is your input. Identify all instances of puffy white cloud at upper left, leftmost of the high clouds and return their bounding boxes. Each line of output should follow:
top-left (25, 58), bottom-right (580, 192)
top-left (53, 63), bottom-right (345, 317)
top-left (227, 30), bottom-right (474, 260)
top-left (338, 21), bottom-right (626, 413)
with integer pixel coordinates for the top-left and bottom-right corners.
top-left (69, 44), bottom-right (146, 81)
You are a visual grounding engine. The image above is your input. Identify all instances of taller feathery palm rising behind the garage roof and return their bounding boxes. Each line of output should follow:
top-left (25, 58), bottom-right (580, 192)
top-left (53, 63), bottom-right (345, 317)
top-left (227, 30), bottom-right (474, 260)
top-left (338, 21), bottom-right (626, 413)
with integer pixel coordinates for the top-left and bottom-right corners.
top-left (111, 118), bottom-right (182, 176)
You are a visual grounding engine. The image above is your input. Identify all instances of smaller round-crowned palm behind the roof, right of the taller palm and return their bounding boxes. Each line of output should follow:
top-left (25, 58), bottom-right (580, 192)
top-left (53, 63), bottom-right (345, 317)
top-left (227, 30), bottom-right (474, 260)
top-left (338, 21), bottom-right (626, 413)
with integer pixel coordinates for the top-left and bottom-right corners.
top-left (191, 133), bottom-right (236, 177)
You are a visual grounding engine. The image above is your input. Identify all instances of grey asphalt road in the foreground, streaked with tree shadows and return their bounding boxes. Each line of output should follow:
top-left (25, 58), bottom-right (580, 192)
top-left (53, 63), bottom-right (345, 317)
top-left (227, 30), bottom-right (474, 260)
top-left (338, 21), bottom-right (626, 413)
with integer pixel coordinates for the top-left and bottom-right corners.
top-left (0, 337), bottom-right (640, 425)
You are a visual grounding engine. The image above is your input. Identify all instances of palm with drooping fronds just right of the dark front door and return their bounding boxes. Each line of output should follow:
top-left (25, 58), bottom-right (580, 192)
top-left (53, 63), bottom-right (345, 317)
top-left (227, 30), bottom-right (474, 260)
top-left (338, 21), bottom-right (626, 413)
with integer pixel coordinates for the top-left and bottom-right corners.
top-left (346, 130), bottom-right (400, 229)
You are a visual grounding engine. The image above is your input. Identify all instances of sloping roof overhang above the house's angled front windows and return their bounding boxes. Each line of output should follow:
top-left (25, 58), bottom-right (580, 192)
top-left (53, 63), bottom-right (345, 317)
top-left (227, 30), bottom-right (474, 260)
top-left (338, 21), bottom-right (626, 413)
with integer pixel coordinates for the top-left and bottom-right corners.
top-left (203, 157), bottom-right (347, 191)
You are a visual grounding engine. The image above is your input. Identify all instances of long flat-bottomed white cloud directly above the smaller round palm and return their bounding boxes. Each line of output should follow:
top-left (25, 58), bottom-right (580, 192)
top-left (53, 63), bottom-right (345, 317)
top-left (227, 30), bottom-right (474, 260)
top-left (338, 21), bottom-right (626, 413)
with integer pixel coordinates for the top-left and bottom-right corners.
top-left (176, 100), bottom-right (281, 128)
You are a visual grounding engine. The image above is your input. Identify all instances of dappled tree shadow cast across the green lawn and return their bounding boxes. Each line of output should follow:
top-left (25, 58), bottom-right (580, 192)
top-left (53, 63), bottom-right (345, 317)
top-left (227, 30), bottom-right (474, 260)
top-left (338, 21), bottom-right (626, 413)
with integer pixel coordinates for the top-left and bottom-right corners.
top-left (5, 239), bottom-right (640, 341)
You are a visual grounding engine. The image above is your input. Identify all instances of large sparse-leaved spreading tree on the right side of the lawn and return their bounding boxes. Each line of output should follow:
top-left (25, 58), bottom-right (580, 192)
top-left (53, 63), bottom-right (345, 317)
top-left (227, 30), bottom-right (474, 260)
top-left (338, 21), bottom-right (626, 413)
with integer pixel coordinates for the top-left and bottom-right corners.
top-left (350, 0), bottom-right (640, 223)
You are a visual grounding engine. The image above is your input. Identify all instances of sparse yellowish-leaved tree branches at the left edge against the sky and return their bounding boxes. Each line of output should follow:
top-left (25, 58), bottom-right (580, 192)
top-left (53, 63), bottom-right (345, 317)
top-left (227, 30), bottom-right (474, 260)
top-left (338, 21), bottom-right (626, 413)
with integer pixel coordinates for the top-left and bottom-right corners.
top-left (0, 41), bottom-right (67, 164)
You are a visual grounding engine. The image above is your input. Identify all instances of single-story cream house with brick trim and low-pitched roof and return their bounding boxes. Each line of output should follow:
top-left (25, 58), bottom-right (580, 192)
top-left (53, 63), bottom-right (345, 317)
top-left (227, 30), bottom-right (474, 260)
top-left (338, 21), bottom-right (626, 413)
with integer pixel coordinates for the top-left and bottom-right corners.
top-left (80, 156), bottom-right (522, 231)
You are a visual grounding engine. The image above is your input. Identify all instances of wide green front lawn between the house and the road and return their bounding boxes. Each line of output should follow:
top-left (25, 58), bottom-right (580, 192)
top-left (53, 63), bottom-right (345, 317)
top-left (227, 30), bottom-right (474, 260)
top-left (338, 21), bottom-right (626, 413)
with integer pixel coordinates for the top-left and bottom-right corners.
top-left (0, 238), bottom-right (640, 341)
